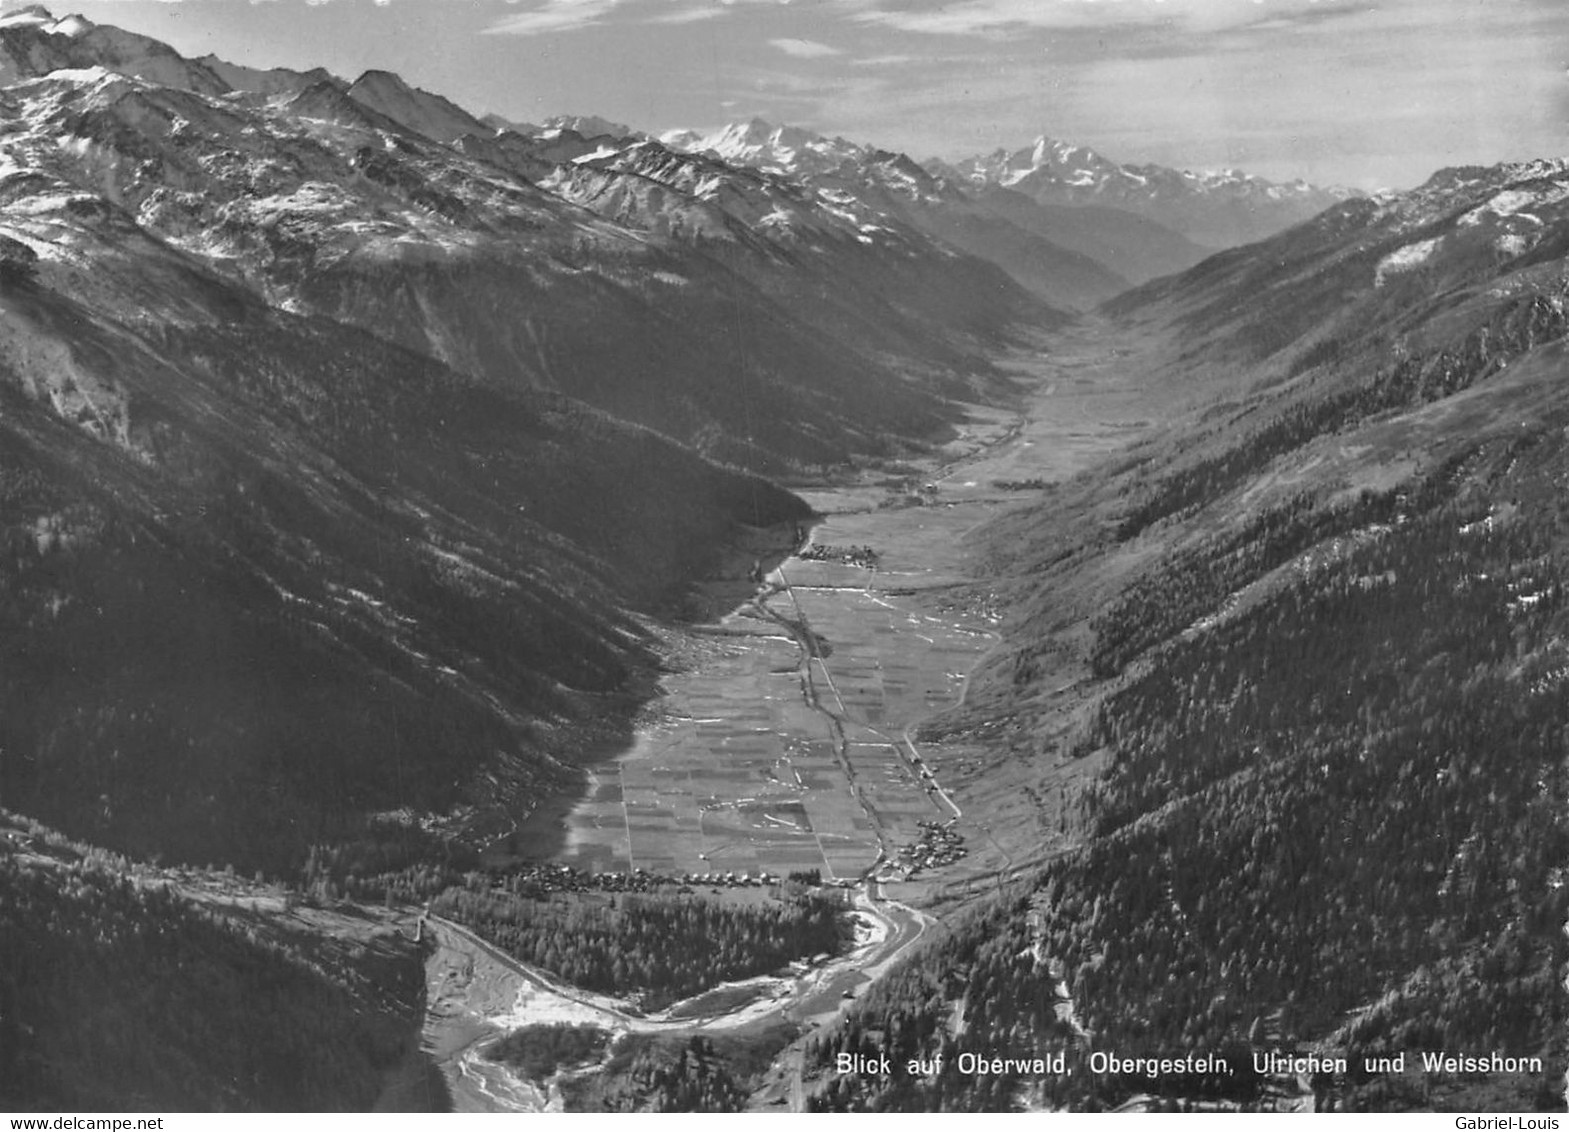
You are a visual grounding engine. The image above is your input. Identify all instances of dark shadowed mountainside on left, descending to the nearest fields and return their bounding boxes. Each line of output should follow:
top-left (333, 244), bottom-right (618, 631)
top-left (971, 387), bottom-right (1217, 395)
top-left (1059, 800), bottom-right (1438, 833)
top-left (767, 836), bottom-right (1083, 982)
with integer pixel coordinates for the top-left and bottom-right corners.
top-left (0, 130), bottom-right (805, 868)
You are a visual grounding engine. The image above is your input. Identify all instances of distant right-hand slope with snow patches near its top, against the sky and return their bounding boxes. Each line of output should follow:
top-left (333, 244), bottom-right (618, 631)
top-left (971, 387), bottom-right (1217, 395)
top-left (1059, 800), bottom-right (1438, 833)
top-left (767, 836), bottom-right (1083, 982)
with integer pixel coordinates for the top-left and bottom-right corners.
top-left (1114, 160), bottom-right (1569, 371)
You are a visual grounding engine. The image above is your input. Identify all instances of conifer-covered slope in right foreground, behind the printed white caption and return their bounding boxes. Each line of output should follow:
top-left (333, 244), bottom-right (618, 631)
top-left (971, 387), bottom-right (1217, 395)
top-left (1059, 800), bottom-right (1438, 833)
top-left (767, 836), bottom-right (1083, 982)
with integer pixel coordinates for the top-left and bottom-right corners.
top-left (813, 411), bottom-right (1569, 1110)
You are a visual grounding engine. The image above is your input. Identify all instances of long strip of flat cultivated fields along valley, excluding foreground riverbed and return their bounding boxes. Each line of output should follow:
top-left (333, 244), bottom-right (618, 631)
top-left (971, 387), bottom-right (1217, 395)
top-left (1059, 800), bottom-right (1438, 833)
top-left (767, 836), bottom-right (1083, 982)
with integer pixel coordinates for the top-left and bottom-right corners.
top-left (557, 340), bottom-right (1147, 879)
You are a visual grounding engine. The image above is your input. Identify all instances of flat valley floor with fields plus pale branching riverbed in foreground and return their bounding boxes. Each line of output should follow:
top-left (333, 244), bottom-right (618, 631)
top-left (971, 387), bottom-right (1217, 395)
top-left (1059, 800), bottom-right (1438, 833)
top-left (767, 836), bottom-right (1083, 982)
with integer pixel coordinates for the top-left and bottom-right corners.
top-left (425, 320), bottom-right (1186, 1110)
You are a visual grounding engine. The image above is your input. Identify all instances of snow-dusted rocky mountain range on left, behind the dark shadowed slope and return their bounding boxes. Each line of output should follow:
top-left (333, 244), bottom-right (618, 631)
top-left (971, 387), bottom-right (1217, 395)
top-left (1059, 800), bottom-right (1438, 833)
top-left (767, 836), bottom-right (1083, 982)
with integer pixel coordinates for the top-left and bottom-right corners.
top-left (0, 16), bottom-right (1053, 471)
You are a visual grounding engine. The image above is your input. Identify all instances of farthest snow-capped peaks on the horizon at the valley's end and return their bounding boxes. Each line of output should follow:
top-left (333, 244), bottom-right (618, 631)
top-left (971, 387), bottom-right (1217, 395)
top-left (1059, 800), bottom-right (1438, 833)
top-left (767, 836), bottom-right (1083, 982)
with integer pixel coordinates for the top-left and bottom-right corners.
top-left (927, 135), bottom-right (1349, 248)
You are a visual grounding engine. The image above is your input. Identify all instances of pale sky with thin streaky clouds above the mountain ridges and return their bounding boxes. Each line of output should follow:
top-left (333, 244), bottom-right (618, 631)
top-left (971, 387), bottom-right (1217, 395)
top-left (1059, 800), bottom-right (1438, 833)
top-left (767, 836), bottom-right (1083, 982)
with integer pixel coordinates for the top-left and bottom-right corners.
top-left (55, 0), bottom-right (1569, 188)
